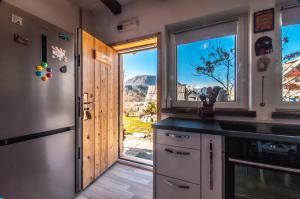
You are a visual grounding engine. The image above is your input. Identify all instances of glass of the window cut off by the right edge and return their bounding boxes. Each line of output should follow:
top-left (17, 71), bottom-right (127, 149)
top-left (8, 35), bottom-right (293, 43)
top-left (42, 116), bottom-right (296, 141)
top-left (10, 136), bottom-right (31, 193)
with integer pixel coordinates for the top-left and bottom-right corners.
top-left (281, 7), bottom-right (300, 103)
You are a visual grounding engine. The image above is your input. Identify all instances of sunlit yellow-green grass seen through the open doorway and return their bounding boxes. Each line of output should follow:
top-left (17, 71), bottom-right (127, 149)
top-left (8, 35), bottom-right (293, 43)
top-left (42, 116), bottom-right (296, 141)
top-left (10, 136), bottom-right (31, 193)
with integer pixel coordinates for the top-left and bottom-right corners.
top-left (123, 115), bottom-right (153, 135)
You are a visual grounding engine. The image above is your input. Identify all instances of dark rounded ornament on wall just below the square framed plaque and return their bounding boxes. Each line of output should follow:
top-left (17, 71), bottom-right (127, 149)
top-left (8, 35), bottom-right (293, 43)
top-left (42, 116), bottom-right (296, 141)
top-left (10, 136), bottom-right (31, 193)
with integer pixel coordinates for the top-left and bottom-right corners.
top-left (255, 36), bottom-right (273, 56)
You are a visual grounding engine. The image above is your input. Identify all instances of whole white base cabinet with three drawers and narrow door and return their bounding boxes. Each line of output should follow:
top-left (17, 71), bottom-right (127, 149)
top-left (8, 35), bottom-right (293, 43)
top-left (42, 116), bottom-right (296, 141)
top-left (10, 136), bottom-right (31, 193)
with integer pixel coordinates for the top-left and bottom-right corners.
top-left (154, 129), bottom-right (224, 199)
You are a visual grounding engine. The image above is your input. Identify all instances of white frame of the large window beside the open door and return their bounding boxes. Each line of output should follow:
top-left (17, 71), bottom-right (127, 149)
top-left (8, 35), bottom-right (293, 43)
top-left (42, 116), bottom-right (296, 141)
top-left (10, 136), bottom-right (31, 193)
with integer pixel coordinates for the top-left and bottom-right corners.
top-left (167, 12), bottom-right (250, 109)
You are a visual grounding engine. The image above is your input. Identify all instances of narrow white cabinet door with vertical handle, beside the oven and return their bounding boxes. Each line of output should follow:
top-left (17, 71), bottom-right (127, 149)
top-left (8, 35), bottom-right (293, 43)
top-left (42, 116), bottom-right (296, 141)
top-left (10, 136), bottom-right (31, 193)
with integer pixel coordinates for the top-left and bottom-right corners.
top-left (201, 134), bottom-right (224, 199)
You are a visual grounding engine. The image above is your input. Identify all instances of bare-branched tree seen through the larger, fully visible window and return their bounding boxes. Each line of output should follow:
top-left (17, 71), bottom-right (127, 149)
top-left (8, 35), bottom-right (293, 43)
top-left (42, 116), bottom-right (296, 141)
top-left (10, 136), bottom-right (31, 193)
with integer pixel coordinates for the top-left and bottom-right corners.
top-left (196, 45), bottom-right (235, 98)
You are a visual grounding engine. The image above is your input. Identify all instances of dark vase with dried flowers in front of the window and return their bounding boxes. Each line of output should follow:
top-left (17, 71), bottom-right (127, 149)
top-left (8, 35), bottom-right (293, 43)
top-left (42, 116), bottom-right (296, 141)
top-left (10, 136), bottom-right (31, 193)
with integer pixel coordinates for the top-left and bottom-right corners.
top-left (198, 86), bottom-right (221, 119)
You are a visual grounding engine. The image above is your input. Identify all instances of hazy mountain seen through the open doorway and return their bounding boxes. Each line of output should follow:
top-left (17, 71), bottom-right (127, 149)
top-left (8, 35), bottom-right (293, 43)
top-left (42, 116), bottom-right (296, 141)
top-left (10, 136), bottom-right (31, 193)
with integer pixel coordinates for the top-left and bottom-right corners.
top-left (124, 75), bottom-right (156, 102)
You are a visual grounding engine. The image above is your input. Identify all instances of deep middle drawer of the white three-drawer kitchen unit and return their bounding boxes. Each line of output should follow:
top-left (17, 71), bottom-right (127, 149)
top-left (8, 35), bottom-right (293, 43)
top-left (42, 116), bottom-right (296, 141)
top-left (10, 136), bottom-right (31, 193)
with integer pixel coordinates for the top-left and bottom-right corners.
top-left (156, 144), bottom-right (200, 184)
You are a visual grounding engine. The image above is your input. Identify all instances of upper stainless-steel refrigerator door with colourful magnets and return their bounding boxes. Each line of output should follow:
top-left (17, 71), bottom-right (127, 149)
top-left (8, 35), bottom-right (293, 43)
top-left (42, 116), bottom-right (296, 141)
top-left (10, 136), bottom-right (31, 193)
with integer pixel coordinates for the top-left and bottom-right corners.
top-left (0, 2), bottom-right (75, 140)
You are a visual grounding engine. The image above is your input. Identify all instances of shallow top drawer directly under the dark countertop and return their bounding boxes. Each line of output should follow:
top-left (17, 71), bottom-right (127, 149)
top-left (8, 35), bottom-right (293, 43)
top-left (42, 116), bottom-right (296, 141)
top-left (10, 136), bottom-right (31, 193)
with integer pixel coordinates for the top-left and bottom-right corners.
top-left (156, 130), bottom-right (201, 149)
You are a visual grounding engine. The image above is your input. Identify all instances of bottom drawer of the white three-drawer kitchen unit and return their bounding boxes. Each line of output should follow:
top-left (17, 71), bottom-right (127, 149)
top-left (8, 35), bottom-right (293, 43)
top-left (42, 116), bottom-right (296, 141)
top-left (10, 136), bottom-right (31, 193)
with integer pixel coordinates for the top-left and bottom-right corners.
top-left (156, 175), bottom-right (200, 199)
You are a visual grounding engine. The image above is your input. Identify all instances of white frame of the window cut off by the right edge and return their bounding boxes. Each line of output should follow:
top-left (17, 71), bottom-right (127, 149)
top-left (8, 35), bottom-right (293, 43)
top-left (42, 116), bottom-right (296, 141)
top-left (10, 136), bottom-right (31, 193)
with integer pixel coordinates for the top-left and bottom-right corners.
top-left (275, 4), bottom-right (300, 110)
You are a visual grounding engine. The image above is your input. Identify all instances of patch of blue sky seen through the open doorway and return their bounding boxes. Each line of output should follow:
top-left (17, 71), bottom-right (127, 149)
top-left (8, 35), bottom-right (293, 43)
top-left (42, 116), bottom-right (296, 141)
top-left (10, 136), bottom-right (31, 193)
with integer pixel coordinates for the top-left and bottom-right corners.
top-left (123, 48), bottom-right (157, 82)
